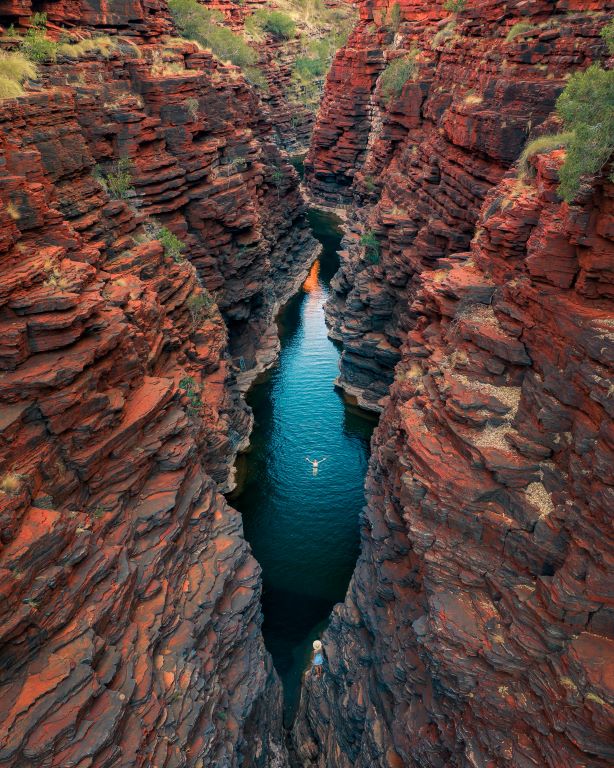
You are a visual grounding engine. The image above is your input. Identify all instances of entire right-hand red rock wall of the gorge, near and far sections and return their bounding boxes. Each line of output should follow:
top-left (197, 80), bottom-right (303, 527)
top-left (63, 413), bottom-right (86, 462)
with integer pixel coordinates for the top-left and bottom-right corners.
top-left (294, 2), bottom-right (614, 768)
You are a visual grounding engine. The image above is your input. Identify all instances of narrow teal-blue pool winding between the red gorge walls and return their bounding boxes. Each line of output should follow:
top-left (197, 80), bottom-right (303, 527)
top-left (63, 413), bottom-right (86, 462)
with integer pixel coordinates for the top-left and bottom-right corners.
top-left (232, 210), bottom-right (375, 720)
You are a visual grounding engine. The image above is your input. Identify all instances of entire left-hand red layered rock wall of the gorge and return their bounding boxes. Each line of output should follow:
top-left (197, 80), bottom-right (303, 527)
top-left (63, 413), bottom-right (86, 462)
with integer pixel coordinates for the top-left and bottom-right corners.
top-left (0, 3), bottom-right (315, 768)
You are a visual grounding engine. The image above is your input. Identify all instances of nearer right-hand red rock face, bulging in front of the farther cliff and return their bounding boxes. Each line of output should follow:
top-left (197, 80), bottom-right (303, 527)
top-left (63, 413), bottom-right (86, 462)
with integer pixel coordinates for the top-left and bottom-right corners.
top-left (295, 142), bottom-right (614, 768)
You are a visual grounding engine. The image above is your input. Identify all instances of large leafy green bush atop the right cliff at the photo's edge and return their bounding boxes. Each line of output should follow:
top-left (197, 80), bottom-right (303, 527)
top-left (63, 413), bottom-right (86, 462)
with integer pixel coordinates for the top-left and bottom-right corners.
top-left (556, 64), bottom-right (614, 202)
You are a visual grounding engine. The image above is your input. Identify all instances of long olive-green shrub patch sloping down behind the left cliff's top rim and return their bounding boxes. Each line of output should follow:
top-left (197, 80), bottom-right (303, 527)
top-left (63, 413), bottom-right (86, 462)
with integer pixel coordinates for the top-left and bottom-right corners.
top-left (168, 0), bottom-right (258, 75)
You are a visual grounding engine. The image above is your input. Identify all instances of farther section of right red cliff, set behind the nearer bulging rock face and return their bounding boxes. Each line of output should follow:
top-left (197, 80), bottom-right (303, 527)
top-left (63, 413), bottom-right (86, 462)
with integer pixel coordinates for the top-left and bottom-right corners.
top-left (305, 2), bottom-right (608, 410)
